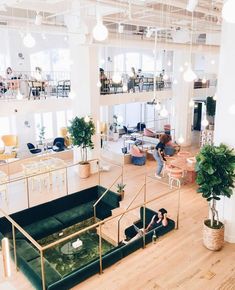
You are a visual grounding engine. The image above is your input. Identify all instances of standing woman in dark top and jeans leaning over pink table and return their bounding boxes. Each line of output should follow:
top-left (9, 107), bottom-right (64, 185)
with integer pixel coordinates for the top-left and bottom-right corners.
top-left (153, 134), bottom-right (171, 179)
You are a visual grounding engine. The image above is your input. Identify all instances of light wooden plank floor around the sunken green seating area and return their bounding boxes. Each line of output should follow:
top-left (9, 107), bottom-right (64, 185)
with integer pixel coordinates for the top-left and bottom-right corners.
top-left (0, 151), bottom-right (235, 290)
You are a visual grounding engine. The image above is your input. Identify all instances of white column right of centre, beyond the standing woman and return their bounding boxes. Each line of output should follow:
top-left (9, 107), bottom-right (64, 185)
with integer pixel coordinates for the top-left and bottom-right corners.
top-left (171, 51), bottom-right (193, 146)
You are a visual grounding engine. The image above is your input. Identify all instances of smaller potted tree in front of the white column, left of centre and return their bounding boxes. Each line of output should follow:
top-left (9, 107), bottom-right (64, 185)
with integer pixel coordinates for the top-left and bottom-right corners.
top-left (68, 117), bottom-right (95, 178)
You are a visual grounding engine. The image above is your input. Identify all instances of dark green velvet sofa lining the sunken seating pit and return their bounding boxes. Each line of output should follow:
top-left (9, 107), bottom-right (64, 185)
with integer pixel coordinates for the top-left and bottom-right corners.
top-left (0, 191), bottom-right (174, 290)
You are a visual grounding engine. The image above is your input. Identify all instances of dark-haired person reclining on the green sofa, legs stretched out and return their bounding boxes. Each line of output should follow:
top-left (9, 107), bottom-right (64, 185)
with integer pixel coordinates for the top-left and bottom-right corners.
top-left (122, 208), bottom-right (168, 244)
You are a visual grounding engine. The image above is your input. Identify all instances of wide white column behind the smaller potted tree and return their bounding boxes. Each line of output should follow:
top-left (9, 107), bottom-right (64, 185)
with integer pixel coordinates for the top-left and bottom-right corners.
top-left (69, 35), bottom-right (100, 158)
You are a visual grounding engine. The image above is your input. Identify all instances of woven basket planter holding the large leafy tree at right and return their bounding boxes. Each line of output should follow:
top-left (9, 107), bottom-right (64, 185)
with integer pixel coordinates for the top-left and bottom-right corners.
top-left (203, 220), bottom-right (224, 251)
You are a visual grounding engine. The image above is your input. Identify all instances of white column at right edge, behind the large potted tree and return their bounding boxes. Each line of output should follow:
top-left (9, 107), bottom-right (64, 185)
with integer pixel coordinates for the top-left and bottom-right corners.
top-left (215, 22), bottom-right (235, 243)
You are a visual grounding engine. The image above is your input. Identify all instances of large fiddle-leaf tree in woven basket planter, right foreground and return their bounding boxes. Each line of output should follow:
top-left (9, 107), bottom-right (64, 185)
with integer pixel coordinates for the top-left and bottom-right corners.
top-left (196, 144), bottom-right (235, 251)
